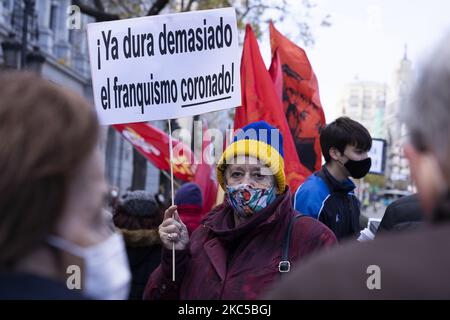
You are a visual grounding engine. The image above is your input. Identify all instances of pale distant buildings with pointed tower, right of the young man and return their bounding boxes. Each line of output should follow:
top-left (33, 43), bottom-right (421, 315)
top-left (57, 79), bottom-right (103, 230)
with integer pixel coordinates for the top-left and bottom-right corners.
top-left (338, 49), bottom-right (414, 191)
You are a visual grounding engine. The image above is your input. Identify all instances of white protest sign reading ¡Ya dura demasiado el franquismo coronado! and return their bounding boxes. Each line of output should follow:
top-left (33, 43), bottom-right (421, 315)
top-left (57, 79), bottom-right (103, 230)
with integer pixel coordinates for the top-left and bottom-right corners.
top-left (87, 8), bottom-right (241, 125)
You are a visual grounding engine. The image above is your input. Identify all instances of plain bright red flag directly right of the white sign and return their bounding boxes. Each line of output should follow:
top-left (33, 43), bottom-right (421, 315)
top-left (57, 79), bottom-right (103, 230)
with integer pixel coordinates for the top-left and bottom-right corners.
top-left (234, 25), bottom-right (307, 190)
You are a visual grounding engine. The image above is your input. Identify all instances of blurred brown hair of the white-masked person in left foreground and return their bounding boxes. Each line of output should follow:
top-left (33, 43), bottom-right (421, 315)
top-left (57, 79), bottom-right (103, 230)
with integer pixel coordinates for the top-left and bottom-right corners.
top-left (0, 72), bottom-right (98, 268)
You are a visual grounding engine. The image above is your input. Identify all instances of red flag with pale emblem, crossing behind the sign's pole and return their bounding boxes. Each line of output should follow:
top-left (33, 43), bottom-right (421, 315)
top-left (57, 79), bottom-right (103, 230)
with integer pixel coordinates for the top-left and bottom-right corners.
top-left (113, 122), bottom-right (194, 181)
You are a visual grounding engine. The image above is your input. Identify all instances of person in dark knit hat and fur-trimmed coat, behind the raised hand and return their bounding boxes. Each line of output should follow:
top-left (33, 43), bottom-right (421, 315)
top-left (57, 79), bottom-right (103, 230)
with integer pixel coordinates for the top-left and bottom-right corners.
top-left (113, 190), bottom-right (163, 300)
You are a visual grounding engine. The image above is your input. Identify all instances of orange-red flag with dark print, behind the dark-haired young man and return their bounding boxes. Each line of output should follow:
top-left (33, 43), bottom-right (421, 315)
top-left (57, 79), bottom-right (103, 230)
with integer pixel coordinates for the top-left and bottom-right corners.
top-left (270, 22), bottom-right (325, 174)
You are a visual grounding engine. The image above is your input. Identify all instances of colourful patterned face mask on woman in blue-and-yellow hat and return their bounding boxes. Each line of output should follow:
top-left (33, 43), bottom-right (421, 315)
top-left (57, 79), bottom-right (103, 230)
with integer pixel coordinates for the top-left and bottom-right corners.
top-left (227, 184), bottom-right (276, 218)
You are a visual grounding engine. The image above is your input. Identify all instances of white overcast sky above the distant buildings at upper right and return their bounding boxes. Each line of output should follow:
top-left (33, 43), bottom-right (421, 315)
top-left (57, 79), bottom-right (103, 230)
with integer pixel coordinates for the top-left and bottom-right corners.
top-left (260, 0), bottom-right (450, 122)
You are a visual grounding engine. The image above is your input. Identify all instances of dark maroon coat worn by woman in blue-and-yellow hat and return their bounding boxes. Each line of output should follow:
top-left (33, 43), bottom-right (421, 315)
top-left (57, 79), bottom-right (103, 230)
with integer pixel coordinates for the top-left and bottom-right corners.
top-left (144, 190), bottom-right (337, 300)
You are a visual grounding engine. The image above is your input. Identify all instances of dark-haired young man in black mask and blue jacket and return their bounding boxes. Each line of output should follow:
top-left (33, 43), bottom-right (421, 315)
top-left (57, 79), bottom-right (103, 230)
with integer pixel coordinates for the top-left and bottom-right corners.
top-left (294, 117), bottom-right (372, 240)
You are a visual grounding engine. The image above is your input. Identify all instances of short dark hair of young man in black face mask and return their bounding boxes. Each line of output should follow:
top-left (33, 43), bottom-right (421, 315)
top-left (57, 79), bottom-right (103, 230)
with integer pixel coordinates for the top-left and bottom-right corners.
top-left (320, 117), bottom-right (372, 162)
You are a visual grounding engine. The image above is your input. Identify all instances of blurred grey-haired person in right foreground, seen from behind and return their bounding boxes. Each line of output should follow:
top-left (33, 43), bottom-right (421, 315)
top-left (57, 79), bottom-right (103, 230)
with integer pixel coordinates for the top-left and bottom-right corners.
top-left (267, 38), bottom-right (450, 299)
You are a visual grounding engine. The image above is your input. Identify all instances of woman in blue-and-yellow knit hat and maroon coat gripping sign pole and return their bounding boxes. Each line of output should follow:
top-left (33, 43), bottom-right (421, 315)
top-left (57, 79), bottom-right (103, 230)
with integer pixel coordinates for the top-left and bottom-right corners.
top-left (144, 122), bottom-right (336, 299)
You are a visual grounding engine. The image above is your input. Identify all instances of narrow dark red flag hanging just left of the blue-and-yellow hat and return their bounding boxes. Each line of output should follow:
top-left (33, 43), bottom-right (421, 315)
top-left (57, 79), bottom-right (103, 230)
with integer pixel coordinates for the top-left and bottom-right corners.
top-left (194, 122), bottom-right (218, 216)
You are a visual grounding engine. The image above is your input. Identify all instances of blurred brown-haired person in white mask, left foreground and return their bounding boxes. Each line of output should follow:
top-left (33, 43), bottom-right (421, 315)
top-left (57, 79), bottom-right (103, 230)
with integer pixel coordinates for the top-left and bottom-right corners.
top-left (0, 73), bottom-right (130, 299)
